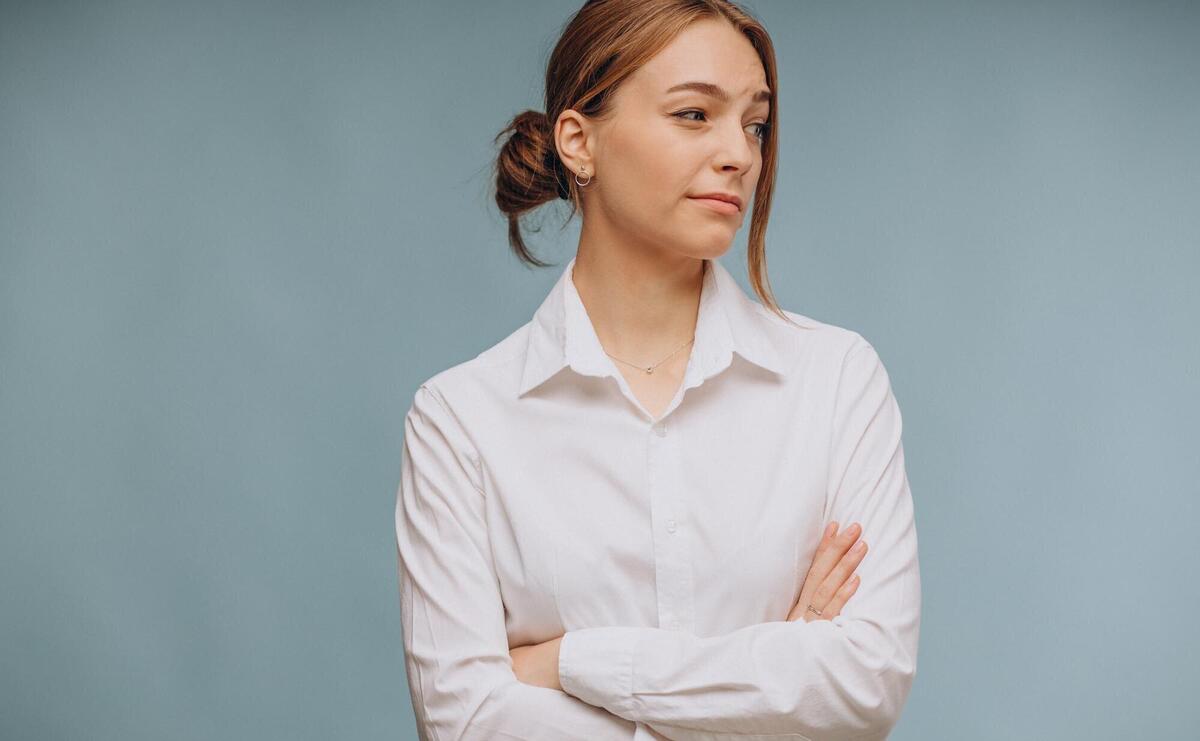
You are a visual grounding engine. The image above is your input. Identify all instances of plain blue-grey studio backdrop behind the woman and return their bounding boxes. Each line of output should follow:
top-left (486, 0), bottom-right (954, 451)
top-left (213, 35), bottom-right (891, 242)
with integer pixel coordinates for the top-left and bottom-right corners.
top-left (0, 0), bottom-right (1200, 741)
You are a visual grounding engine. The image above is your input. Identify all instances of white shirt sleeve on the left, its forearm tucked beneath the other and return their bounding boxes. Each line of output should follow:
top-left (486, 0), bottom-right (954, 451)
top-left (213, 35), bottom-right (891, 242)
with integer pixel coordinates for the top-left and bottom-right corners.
top-left (396, 385), bottom-right (648, 741)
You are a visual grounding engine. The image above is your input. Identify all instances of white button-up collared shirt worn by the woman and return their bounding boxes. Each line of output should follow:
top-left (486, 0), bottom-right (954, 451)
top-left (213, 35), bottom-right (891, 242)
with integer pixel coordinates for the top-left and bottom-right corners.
top-left (396, 259), bottom-right (920, 741)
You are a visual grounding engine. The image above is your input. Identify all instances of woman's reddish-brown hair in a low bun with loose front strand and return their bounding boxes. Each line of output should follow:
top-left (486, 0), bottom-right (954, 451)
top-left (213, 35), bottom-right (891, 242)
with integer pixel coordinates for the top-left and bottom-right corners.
top-left (494, 0), bottom-right (786, 319)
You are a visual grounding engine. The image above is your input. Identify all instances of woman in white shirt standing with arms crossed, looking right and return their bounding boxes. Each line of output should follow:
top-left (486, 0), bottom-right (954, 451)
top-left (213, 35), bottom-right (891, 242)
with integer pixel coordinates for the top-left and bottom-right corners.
top-left (396, 0), bottom-right (920, 741)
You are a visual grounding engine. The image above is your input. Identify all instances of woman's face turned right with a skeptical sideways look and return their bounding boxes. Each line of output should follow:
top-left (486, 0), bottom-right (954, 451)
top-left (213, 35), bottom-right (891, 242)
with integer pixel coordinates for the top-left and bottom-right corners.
top-left (576, 20), bottom-right (770, 258)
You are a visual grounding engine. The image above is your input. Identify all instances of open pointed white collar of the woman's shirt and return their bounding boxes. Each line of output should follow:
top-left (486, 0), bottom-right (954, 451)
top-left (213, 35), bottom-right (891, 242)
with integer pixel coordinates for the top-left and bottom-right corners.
top-left (517, 258), bottom-right (803, 396)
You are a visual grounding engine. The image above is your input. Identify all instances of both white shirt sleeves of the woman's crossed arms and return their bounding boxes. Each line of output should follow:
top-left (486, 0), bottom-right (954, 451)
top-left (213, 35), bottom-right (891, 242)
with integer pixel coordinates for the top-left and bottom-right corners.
top-left (396, 341), bottom-right (920, 741)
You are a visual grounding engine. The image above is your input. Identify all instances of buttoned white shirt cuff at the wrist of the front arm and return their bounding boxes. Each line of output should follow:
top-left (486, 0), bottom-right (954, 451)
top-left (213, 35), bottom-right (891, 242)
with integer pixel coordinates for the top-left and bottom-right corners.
top-left (558, 627), bottom-right (641, 712)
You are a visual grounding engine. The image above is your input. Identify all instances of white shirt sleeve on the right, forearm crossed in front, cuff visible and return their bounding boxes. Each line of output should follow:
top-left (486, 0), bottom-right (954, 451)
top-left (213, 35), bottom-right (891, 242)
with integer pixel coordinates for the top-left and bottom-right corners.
top-left (559, 336), bottom-right (920, 741)
